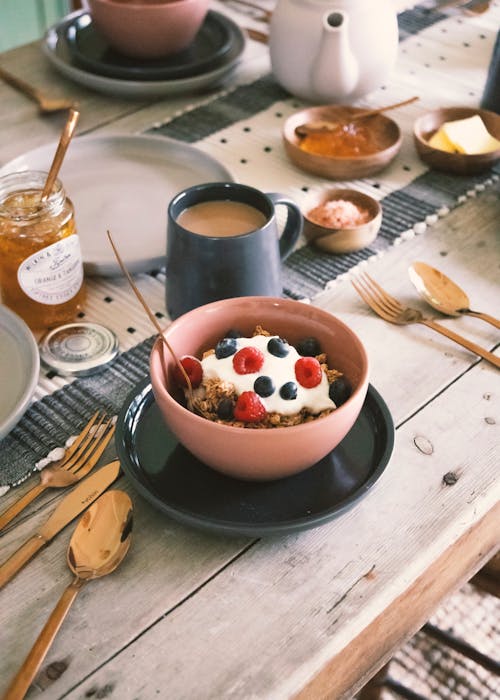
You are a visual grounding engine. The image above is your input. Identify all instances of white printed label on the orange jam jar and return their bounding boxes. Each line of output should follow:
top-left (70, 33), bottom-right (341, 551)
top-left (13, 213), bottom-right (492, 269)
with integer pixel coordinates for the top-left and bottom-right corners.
top-left (17, 234), bottom-right (83, 305)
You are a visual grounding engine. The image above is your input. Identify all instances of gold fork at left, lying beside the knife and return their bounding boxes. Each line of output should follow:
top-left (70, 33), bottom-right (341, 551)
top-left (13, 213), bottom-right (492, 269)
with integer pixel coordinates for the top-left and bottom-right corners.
top-left (0, 417), bottom-right (115, 531)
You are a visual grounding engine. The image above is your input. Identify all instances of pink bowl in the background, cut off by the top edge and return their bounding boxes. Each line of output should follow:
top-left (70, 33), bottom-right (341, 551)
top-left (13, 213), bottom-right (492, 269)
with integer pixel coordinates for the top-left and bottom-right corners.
top-left (87, 0), bottom-right (210, 59)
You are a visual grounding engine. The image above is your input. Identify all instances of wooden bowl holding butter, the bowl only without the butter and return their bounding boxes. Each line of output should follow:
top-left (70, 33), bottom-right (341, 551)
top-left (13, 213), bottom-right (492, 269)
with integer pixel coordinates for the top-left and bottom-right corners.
top-left (413, 107), bottom-right (500, 175)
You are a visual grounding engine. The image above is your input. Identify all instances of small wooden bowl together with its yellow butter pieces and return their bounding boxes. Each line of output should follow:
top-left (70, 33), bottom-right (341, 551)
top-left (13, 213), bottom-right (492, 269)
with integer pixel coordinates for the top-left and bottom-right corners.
top-left (413, 107), bottom-right (500, 175)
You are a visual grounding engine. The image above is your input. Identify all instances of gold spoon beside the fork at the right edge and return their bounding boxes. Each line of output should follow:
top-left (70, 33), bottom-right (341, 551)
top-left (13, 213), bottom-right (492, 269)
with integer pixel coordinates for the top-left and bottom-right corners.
top-left (408, 262), bottom-right (500, 328)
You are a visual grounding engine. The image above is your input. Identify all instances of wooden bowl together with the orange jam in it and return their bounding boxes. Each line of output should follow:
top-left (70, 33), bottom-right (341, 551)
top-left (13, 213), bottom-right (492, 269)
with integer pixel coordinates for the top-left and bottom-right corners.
top-left (283, 105), bottom-right (402, 180)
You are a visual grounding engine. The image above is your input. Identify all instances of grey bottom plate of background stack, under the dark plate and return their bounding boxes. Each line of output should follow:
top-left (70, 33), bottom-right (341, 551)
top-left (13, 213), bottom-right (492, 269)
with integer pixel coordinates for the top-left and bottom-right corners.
top-left (42, 13), bottom-right (245, 99)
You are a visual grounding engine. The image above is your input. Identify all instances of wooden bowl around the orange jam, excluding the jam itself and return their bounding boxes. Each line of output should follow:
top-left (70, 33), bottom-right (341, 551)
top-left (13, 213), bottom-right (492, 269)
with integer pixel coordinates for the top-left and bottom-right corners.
top-left (283, 105), bottom-right (402, 180)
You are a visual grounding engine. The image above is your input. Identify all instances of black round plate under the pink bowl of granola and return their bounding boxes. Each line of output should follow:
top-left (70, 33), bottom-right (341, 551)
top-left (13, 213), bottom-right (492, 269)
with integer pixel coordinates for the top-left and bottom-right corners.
top-left (116, 379), bottom-right (394, 536)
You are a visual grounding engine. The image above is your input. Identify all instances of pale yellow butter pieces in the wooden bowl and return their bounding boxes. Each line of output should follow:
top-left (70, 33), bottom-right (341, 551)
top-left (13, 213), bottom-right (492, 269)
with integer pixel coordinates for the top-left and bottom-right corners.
top-left (429, 114), bottom-right (500, 155)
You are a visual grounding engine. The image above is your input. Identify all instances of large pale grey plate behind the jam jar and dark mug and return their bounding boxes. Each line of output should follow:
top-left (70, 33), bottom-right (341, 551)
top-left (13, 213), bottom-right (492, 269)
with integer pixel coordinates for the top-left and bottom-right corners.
top-left (0, 135), bottom-right (233, 276)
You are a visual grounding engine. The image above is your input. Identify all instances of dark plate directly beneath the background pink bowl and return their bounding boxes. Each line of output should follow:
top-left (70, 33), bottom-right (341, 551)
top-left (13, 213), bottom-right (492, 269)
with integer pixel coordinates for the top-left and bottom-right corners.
top-left (64, 10), bottom-right (240, 80)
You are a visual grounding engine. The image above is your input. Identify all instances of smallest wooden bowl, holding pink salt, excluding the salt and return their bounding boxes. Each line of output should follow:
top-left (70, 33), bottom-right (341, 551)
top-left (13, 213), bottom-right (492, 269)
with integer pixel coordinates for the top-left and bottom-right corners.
top-left (302, 188), bottom-right (382, 255)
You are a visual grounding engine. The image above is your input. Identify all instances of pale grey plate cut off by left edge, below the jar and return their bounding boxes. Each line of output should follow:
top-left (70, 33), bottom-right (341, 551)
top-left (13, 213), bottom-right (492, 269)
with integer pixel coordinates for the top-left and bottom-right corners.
top-left (0, 305), bottom-right (40, 439)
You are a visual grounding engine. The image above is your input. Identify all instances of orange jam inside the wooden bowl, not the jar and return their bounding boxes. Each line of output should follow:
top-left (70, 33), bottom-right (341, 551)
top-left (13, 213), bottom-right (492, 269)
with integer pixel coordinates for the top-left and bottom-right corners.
top-left (299, 122), bottom-right (378, 158)
